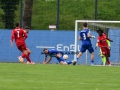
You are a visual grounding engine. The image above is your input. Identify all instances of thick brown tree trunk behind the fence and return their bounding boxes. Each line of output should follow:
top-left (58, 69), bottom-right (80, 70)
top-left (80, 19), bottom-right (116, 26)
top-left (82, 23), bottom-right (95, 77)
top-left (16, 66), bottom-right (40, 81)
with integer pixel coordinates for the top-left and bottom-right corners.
top-left (22, 0), bottom-right (33, 27)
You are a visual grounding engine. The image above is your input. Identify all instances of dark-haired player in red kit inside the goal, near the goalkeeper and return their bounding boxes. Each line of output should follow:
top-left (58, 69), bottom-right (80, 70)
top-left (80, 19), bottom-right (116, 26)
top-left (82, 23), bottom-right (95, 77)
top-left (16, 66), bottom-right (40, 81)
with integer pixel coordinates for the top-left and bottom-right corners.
top-left (97, 29), bottom-right (113, 65)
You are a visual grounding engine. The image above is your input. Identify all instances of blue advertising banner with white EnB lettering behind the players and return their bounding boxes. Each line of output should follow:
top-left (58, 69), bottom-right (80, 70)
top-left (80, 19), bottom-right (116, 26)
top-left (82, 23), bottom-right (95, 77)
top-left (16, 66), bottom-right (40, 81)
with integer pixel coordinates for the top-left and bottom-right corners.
top-left (0, 30), bottom-right (120, 64)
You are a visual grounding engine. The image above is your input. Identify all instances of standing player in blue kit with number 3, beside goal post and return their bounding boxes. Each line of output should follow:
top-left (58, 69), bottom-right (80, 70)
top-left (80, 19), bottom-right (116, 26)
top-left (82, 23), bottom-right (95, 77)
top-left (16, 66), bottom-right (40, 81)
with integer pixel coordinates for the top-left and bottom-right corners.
top-left (73, 22), bottom-right (95, 65)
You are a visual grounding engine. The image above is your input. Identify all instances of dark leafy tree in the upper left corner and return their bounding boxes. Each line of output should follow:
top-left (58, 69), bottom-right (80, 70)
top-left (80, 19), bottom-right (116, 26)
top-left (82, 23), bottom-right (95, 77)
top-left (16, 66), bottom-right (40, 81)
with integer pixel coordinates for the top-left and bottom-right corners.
top-left (0, 0), bottom-right (19, 29)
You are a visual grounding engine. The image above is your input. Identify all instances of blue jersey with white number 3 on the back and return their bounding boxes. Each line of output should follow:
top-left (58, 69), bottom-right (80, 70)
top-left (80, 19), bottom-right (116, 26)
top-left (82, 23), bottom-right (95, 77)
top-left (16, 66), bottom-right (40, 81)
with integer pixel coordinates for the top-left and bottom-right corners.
top-left (79, 28), bottom-right (91, 45)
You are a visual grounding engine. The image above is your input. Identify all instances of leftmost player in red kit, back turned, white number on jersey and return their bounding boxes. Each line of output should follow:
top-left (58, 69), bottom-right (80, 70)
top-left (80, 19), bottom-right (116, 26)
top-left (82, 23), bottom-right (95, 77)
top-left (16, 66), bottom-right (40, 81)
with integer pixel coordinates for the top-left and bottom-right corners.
top-left (10, 23), bottom-right (34, 64)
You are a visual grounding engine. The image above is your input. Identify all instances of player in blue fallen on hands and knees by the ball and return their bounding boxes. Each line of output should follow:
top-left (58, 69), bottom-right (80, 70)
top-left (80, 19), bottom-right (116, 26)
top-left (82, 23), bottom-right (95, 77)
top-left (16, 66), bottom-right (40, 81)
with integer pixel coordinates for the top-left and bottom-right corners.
top-left (43, 48), bottom-right (76, 65)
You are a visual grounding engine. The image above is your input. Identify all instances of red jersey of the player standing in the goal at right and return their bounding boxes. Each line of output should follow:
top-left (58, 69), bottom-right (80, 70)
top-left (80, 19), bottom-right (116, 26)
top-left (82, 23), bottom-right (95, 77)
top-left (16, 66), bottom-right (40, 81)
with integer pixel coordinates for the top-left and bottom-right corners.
top-left (97, 34), bottom-right (108, 47)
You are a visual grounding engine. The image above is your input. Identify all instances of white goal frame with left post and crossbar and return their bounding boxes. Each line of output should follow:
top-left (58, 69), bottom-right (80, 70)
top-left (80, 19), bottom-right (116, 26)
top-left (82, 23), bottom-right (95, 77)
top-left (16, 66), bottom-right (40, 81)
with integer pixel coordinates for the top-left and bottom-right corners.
top-left (74, 20), bottom-right (120, 64)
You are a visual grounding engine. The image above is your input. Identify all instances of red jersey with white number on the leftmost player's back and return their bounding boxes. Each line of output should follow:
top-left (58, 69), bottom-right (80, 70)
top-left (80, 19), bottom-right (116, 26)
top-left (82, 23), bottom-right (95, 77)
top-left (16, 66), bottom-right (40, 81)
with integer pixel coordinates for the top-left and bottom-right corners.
top-left (11, 28), bottom-right (27, 46)
